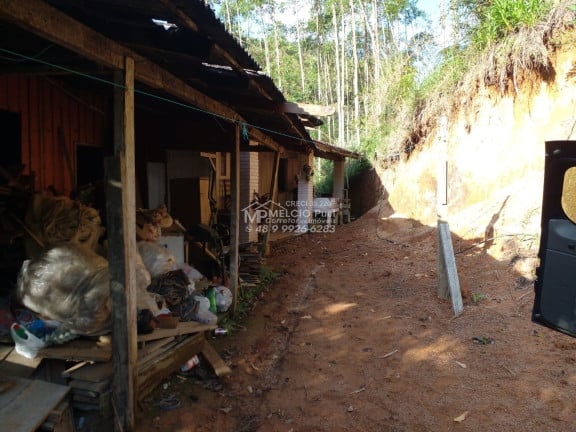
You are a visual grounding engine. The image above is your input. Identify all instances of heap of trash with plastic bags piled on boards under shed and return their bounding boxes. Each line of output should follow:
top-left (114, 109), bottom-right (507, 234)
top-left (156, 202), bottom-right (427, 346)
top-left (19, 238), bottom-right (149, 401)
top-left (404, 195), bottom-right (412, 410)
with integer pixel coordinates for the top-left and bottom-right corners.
top-left (10, 196), bottom-right (232, 358)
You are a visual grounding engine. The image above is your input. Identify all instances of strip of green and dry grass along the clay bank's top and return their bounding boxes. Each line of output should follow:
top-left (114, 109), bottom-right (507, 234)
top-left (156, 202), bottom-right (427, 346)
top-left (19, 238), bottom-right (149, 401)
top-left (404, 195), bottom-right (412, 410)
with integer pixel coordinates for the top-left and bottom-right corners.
top-left (372, 0), bottom-right (576, 160)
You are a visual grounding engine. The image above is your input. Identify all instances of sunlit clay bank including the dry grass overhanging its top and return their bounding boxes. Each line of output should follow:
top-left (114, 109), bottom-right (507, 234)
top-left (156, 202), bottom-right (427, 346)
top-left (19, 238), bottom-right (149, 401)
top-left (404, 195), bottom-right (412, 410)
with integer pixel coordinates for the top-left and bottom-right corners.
top-left (375, 2), bottom-right (576, 241)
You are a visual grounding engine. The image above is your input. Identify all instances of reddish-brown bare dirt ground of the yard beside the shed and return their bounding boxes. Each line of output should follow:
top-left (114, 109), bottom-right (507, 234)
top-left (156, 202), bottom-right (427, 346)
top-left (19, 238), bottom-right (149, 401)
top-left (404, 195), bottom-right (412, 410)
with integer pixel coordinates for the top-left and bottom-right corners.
top-left (137, 203), bottom-right (576, 432)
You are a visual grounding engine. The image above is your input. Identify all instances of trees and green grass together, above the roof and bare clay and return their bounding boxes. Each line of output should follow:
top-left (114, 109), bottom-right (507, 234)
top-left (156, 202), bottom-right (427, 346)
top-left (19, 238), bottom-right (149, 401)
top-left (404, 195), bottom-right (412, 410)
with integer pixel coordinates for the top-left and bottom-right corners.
top-left (208, 0), bottom-right (558, 167)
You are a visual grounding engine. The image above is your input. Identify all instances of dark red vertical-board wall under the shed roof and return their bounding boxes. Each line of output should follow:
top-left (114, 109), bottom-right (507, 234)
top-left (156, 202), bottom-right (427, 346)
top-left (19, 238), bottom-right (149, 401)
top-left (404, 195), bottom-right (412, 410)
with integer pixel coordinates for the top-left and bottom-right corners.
top-left (0, 75), bottom-right (112, 195)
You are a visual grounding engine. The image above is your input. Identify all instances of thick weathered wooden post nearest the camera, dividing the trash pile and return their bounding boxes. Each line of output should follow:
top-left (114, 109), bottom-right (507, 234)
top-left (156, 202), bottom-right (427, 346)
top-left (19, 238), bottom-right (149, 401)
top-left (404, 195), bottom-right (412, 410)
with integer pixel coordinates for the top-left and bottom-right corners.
top-left (106, 58), bottom-right (138, 432)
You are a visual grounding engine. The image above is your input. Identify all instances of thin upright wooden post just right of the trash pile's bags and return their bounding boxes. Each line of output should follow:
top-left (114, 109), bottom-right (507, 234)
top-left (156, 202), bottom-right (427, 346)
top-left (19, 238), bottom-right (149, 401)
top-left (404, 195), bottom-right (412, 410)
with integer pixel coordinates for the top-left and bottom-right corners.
top-left (230, 123), bottom-right (241, 314)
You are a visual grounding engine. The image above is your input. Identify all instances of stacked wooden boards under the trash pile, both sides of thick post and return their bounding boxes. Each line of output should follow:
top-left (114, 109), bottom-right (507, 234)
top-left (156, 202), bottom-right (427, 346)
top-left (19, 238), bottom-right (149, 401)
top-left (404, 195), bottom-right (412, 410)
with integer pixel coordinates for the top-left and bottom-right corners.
top-left (0, 321), bottom-right (231, 426)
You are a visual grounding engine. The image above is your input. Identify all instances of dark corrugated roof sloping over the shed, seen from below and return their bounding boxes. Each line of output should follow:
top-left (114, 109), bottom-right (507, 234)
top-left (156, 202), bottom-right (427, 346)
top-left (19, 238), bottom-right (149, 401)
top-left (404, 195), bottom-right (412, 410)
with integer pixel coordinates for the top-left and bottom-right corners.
top-left (0, 0), bottom-right (321, 151)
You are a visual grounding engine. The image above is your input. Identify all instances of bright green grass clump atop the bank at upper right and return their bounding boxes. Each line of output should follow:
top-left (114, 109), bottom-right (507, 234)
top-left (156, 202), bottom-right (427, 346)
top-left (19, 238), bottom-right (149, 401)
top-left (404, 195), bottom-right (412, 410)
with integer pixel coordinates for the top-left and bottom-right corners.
top-left (472, 0), bottom-right (552, 50)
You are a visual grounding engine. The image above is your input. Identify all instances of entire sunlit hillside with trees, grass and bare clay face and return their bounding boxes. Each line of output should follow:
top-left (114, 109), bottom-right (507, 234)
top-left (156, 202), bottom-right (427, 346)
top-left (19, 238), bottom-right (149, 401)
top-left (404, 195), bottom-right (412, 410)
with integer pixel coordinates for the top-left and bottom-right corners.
top-left (210, 0), bottom-right (576, 246)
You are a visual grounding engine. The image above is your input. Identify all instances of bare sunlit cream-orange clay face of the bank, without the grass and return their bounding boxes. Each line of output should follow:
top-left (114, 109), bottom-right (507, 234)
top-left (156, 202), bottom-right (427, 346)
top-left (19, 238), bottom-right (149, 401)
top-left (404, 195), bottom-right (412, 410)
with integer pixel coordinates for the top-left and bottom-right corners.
top-left (376, 50), bottom-right (576, 264)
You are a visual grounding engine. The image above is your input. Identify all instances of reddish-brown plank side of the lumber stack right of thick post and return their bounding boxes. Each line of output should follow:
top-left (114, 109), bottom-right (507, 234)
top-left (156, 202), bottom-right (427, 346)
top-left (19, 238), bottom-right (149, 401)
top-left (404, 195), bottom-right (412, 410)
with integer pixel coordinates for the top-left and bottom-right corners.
top-left (137, 333), bottom-right (206, 400)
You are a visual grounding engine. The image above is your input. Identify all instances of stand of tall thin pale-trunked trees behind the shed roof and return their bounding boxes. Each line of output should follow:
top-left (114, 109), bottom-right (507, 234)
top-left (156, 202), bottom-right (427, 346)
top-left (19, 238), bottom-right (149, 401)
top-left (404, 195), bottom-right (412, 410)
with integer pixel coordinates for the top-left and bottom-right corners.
top-left (206, 0), bottom-right (426, 154)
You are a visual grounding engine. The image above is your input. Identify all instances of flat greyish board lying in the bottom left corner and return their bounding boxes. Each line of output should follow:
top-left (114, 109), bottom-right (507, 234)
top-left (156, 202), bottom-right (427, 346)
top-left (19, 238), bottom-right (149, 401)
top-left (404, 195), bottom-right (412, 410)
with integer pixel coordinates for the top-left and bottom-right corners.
top-left (0, 377), bottom-right (70, 432)
